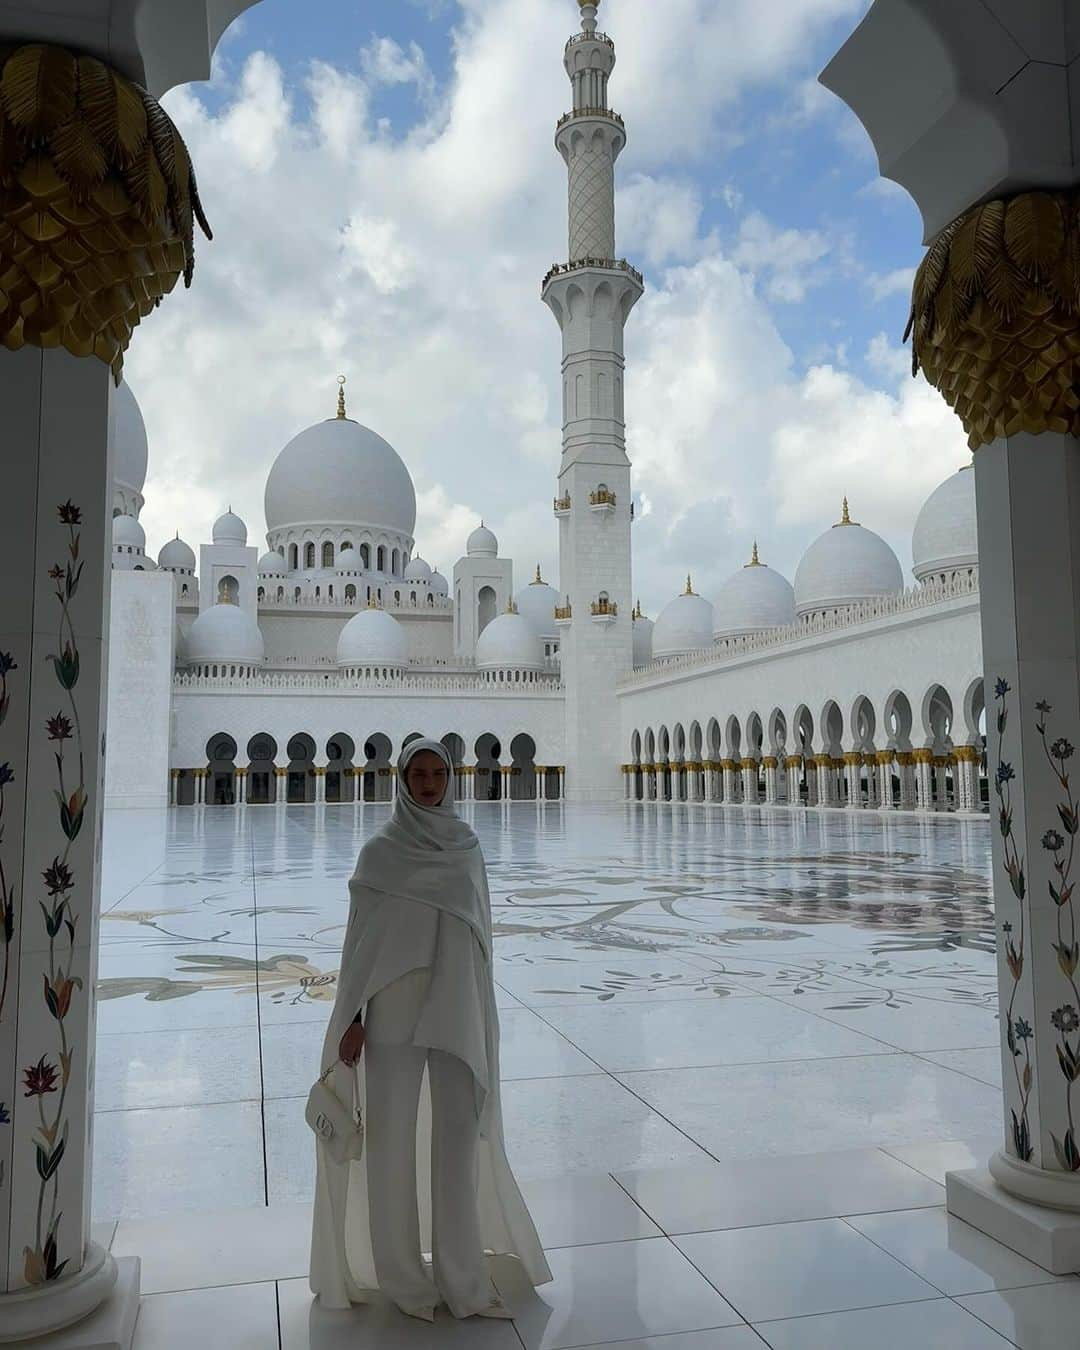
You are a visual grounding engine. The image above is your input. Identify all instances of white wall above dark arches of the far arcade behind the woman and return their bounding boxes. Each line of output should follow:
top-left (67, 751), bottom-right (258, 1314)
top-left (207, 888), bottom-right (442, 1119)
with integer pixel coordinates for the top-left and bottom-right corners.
top-left (171, 683), bottom-right (564, 768)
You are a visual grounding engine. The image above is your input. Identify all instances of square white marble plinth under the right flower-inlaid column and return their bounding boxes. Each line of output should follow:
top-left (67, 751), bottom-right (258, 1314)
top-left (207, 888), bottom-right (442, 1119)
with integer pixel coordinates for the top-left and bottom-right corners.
top-left (945, 1168), bottom-right (1080, 1274)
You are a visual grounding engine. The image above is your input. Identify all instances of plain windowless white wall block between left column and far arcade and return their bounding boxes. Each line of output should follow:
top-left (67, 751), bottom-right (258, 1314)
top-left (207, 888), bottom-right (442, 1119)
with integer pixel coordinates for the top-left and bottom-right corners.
top-left (105, 571), bottom-right (174, 807)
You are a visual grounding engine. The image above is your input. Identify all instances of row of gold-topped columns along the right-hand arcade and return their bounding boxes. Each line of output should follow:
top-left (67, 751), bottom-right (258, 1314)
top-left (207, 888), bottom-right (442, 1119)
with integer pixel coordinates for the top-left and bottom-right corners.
top-left (622, 745), bottom-right (986, 811)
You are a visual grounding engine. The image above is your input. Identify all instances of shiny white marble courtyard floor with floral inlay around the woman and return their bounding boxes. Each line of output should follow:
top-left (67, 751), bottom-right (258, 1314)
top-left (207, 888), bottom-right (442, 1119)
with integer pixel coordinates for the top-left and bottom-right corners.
top-left (95, 803), bottom-right (1080, 1350)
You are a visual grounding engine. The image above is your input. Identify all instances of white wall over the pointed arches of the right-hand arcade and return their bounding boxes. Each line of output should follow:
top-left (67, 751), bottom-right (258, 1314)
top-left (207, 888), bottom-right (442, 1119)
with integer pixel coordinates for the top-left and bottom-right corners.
top-left (617, 591), bottom-right (983, 763)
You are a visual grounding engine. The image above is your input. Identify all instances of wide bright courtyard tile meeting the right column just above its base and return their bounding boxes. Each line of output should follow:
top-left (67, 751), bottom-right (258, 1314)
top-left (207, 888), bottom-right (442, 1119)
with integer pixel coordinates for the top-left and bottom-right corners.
top-left (610, 1054), bottom-right (1000, 1172)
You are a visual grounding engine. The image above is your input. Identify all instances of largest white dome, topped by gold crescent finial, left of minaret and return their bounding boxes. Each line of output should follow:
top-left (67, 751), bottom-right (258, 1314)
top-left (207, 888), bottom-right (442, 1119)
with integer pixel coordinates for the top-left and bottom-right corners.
top-left (265, 417), bottom-right (416, 537)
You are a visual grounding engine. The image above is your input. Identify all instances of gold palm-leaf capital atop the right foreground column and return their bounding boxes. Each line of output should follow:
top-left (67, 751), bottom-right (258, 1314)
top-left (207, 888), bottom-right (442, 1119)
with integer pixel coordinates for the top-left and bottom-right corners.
top-left (905, 188), bottom-right (1080, 450)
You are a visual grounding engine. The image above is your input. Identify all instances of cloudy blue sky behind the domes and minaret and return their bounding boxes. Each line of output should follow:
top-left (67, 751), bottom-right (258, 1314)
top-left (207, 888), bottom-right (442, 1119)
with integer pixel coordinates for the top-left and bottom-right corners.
top-left (126, 0), bottom-right (971, 616)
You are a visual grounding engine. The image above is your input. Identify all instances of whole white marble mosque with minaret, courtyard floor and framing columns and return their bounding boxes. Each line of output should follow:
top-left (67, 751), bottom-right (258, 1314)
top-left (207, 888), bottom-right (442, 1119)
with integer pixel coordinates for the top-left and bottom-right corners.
top-left (0, 0), bottom-right (1080, 1350)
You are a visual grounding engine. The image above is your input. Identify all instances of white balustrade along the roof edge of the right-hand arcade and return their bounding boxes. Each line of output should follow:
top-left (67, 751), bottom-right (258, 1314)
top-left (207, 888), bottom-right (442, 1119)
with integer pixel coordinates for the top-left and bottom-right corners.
top-left (618, 572), bottom-right (979, 689)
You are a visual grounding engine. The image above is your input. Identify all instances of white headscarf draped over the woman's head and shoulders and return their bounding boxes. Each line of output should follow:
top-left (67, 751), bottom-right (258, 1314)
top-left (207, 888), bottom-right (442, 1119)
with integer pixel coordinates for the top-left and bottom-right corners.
top-left (350, 737), bottom-right (491, 963)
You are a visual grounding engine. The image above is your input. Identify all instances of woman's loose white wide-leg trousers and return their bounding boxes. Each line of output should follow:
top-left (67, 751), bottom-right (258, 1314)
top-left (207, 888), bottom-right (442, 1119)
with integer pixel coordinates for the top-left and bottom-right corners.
top-left (363, 968), bottom-right (497, 1318)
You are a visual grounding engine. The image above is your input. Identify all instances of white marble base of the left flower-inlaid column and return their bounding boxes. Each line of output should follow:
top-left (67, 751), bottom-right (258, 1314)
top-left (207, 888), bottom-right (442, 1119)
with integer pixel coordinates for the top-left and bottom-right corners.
top-left (0, 1242), bottom-right (139, 1350)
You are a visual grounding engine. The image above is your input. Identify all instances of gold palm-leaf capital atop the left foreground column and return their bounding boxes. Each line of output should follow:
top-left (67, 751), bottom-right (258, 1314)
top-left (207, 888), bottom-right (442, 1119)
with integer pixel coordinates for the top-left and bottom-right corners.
top-left (0, 43), bottom-right (211, 382)
